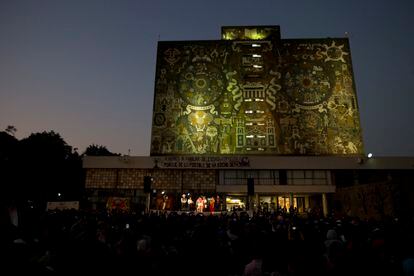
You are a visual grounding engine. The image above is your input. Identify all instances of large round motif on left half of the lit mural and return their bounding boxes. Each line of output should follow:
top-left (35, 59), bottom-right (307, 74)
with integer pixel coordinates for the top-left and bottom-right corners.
top-left (179, 61), bottom-right (225, 106)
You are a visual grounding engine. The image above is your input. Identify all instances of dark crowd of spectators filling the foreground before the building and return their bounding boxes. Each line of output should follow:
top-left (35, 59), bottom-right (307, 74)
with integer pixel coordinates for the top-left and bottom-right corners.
top-left (0, 205), bottom-right (414, 276)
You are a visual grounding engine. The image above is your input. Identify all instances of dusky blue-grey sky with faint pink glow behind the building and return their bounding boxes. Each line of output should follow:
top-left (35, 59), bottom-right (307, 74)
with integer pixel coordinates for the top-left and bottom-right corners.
top-left (0, 0), bottom-right (414, 156)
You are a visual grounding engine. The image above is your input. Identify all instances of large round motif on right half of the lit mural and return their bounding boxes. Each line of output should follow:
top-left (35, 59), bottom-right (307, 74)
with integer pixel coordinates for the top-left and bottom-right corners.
top-left (284, 64), bottom-right (331, 106)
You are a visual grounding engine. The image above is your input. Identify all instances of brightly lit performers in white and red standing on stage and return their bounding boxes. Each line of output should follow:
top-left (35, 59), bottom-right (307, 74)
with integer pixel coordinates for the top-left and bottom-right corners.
top-left (181, 193), bottom-right (221, 213)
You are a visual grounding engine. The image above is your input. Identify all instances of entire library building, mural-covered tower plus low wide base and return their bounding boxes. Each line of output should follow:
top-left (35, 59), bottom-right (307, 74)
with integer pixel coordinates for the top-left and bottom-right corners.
top-left (83, 26), bottom-right (414, 218)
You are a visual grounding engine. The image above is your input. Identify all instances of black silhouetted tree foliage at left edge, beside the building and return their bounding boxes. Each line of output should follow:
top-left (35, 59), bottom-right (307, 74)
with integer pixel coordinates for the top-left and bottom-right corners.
top-left (0, 131), bottom-right (84, 202)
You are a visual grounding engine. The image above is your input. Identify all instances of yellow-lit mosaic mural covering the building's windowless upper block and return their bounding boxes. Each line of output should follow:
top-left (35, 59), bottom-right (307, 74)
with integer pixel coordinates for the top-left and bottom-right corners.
top-left (151, 28), bottom-right (363, 155)
